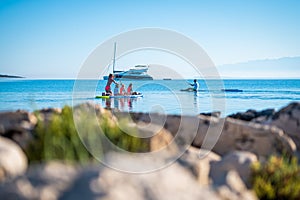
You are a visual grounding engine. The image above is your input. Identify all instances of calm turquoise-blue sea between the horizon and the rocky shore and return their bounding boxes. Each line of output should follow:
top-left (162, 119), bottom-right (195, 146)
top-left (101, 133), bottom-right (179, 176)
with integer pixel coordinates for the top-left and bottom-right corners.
top-left (0, 79), bottom-right (300, 116)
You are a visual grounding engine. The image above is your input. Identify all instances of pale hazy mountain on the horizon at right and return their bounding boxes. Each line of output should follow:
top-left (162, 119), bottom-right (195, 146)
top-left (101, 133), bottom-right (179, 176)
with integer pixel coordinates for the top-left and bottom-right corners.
top-left (217, 56), bottom-right (300, 78)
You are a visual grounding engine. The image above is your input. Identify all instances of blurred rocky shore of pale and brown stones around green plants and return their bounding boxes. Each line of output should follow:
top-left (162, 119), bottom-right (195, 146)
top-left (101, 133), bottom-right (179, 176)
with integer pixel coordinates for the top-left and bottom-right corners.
top-left (0, 102), bottom-right (300, 199)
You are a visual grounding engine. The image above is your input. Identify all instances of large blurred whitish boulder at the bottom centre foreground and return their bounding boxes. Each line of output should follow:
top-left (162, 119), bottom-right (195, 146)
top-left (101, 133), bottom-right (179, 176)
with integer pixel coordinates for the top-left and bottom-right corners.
top-left (62, 159), bottom-right (219, 200)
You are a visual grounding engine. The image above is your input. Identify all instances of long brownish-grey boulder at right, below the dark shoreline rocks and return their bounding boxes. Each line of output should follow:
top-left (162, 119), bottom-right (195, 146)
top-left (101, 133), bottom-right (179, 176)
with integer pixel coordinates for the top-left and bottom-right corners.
top-left (193, 117), bottom-right (296, 158)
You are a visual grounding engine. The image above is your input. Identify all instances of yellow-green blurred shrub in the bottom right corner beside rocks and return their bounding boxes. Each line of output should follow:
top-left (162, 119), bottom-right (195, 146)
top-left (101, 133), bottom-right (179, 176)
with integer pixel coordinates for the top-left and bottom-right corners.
top-left (252, 156), bottom-right (300, 199)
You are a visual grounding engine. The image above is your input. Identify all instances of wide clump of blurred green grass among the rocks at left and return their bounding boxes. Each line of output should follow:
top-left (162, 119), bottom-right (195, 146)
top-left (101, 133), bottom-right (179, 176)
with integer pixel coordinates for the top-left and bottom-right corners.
top-left (25, 106), bottom-right (149, 164)
